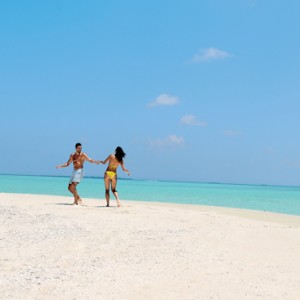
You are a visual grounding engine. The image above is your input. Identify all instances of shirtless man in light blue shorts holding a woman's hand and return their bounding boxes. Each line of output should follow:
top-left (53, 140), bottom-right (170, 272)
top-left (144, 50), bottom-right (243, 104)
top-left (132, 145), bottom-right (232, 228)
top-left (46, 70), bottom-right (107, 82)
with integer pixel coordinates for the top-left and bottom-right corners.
top-left (56, 143), bottom-right (100, 205)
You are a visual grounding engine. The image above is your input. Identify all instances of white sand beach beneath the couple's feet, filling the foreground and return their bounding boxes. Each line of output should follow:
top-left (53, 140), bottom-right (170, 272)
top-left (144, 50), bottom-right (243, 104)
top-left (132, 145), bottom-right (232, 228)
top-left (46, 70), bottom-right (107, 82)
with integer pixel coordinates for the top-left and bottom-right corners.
top-left (0, 194), bottom-right (300, 300)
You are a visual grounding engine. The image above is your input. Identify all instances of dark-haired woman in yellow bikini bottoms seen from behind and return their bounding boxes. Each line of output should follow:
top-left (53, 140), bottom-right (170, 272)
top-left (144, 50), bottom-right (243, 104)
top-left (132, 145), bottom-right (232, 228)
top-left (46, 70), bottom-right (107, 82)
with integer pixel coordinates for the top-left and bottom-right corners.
top-left (102, 147), bottom-right (130, 207)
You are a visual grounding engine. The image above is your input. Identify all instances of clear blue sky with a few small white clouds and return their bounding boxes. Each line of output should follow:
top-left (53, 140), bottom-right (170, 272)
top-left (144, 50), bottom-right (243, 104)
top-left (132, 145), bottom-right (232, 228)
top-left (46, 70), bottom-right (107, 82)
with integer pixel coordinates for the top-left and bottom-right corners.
top-left (0, 0), bottom-right (300, 185)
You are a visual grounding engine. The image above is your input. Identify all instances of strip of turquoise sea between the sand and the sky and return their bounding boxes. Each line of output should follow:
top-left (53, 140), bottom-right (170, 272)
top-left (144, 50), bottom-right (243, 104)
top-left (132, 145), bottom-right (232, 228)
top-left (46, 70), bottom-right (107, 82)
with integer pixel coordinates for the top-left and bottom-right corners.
top-left (0, 175), bottom-right (300, 215)
